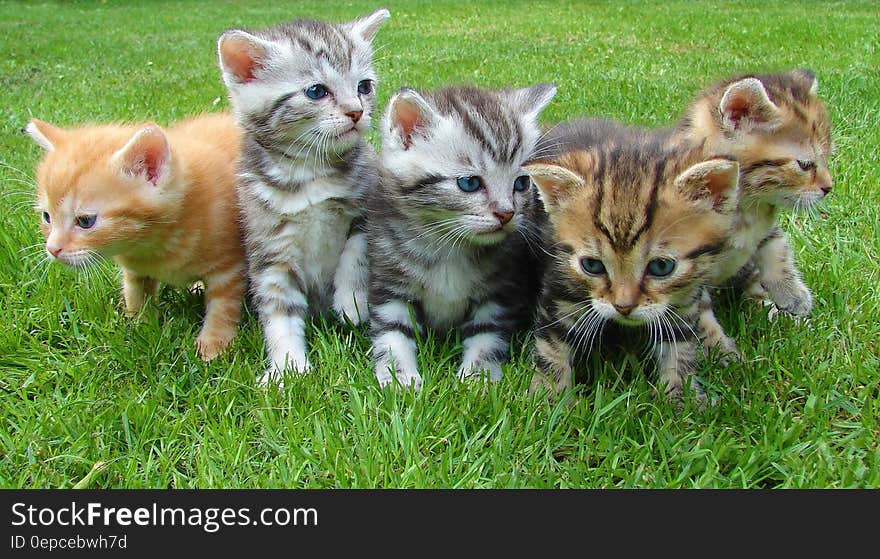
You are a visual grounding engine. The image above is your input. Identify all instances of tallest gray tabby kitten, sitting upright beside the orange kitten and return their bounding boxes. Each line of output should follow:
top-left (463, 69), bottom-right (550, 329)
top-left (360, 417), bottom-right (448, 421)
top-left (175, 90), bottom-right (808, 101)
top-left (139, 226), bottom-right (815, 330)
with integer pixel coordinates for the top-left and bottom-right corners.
top-left (218, 8), bottom-right (390, 384)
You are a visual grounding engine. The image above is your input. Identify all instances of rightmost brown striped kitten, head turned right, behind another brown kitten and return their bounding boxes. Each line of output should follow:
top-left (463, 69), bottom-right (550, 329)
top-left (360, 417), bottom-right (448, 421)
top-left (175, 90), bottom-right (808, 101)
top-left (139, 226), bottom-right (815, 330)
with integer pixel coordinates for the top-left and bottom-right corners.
top-left (673, 69), bottom-right (832, 324)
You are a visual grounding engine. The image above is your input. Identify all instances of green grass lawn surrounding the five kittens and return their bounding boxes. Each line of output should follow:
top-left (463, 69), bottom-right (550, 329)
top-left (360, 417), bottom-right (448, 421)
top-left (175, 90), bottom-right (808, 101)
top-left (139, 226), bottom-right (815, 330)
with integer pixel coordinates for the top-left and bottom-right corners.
top-left (0, 0), bottom-right (880, 488)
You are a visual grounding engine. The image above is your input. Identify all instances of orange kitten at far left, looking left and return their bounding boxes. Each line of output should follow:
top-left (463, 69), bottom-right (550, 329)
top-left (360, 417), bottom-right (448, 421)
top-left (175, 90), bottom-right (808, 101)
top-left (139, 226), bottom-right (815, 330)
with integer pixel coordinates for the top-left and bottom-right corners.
top-left (26, 113), bottom-right (245, 361)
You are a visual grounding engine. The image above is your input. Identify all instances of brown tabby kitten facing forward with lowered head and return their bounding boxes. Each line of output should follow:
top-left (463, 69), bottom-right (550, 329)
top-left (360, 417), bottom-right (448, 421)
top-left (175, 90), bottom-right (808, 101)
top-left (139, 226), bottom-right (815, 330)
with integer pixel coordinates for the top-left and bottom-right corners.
top-left (526, 127), bottom-right (739, 399)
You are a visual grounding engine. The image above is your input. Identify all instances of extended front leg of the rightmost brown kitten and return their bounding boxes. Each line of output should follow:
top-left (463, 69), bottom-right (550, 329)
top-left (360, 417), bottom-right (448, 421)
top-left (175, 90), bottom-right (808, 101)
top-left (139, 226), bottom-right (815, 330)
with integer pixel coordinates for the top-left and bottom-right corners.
top-left (754, 228), bottom-right (813, 316)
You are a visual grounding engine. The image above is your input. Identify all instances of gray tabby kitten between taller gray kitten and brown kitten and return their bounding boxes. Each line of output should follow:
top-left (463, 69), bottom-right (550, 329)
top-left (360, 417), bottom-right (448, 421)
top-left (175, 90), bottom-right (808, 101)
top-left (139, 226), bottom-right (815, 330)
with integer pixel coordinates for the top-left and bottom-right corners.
top-left (367, 84), bottom-right (556, 390)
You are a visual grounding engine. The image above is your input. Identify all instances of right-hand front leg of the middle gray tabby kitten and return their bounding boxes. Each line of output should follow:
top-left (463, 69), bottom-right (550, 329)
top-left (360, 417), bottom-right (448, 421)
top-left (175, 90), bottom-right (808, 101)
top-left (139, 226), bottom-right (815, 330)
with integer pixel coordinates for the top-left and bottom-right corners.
top-left (458, 302), bottom-right (511, 381)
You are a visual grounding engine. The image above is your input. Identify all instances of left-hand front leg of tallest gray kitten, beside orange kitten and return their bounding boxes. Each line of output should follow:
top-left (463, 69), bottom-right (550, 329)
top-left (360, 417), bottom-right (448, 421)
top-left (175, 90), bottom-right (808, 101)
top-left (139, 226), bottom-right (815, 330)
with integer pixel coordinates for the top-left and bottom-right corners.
top-left (251, 264), bottom-right (310, 386)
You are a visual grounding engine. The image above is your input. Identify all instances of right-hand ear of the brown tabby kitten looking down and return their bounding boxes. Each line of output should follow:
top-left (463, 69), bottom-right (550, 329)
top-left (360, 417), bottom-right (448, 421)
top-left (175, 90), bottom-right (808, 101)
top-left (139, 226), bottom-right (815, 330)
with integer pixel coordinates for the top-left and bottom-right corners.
top-left (674, 159), bottom-right (739, 213)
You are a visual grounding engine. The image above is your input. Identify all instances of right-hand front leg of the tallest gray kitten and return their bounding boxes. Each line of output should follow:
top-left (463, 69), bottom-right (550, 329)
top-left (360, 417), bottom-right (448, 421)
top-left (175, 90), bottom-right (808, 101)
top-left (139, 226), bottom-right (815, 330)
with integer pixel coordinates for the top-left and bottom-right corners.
top-left (333, 231), bottom-right (369, 325)
